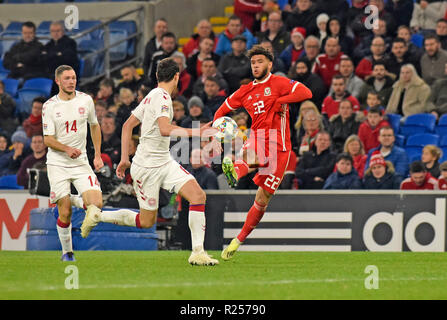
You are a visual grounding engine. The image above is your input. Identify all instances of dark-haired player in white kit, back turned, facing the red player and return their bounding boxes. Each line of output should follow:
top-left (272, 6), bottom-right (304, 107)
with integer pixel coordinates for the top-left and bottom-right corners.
top-left (107, 58), bottom-right (219, 265)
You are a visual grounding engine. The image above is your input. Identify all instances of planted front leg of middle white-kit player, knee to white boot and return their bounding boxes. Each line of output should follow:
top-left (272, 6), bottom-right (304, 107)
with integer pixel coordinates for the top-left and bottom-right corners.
top-left (179, 179), bottom-right (219, 266)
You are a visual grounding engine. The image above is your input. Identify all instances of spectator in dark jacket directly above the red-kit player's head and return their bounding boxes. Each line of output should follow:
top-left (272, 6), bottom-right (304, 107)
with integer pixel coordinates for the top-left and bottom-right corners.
top-left (256, 11), bottom-right (290, 57)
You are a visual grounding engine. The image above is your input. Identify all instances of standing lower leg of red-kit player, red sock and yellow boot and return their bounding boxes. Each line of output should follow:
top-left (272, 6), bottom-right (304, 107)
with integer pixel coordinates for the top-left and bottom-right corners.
top-left (221, 188), bottom-right (273, 260)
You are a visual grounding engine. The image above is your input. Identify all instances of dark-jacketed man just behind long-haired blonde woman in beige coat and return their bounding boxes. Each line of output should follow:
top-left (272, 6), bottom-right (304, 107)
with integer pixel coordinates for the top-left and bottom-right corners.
top-left (385, 38), bottom-right (420, 78)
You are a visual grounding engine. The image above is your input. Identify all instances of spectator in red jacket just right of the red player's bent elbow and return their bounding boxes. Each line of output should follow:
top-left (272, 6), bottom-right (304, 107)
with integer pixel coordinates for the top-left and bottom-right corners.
top-left (321, 74), bottom-right (360, 119)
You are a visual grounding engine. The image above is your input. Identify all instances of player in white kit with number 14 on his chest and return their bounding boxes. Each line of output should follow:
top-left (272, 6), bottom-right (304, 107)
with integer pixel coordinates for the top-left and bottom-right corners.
top-left (42, 65), bottom-right (104, 261)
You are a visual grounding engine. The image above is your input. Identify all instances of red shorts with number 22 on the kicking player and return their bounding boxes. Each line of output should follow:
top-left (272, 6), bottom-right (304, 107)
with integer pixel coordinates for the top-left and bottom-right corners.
top-left (242, 135), bottom-right (291, 194)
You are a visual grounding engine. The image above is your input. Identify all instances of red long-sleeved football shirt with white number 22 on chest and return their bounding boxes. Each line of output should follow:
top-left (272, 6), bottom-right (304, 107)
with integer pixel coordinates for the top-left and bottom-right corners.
top-left (214, 74), bottom-right (312, 152)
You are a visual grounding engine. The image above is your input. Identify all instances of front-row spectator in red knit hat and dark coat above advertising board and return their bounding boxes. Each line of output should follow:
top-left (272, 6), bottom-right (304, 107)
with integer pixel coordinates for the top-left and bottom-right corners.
top-left (363, 151), bottom-right (402, 190)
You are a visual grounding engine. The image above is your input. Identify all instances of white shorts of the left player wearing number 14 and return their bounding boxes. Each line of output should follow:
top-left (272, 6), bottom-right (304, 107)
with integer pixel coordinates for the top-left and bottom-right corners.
top-left (47, 164), bottom-right (101, 203)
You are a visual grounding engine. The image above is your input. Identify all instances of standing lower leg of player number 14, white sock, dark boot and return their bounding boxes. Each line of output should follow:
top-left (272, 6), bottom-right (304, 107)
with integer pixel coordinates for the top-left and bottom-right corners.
top-left (56, 195), bottom-right (75, 261)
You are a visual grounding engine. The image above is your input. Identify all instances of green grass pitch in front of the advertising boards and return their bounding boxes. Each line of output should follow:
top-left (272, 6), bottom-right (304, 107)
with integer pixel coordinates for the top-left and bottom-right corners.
top-left (0, 251), bottom-right (447, 300)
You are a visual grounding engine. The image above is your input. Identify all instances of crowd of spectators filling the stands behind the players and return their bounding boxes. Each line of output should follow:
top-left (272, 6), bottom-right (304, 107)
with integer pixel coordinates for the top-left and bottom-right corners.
top-left (0, 0), bottom-right (447, 189)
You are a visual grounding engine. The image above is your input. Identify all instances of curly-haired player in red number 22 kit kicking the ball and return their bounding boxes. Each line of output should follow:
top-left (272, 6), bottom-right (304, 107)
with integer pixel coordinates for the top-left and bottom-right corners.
top-left (214, 46), bottom-right (312, 260)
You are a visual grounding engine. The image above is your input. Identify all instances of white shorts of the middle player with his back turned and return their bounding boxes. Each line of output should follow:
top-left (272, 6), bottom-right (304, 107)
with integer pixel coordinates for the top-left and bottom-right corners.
top-left (130, 159), bottom-right (195, 211)
